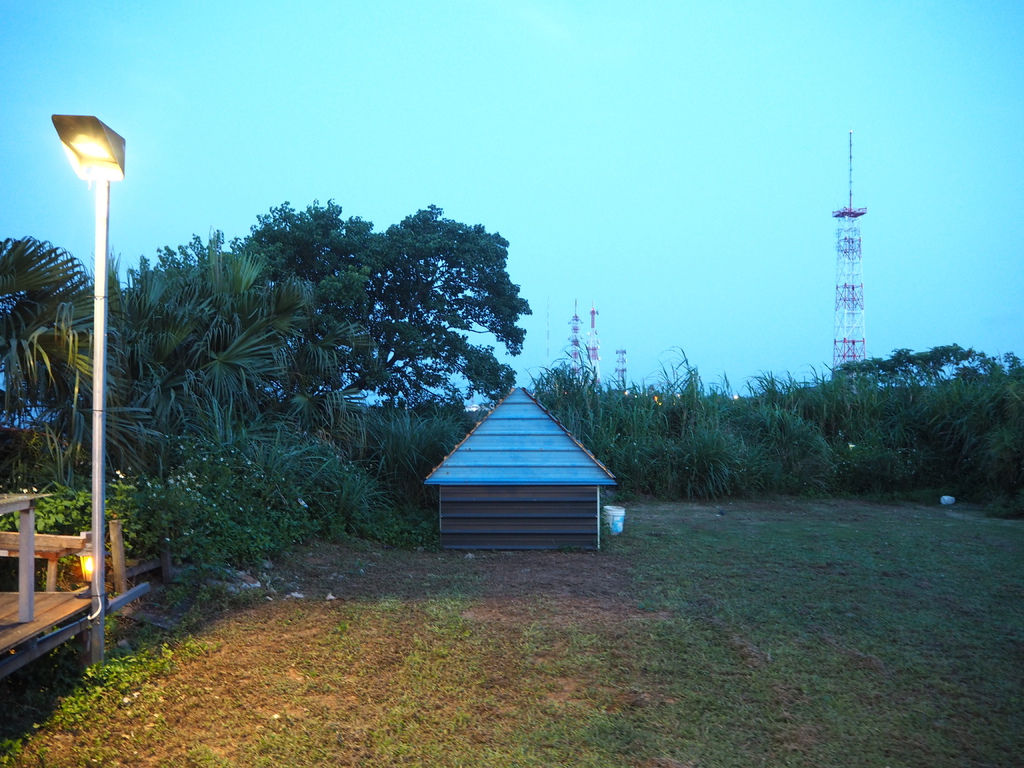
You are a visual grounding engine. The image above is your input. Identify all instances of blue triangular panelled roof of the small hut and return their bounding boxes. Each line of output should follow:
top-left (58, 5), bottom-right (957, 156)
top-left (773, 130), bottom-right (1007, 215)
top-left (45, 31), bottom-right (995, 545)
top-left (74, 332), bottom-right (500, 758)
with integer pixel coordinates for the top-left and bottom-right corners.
top-left (424, 388), bottom-right (615, 485)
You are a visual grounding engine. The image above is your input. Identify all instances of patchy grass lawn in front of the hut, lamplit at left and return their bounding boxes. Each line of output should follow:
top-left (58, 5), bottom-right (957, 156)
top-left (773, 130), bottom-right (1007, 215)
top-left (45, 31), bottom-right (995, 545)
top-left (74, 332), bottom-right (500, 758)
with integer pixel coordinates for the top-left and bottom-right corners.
top-left (0, 499), bottom-right (1024, 768)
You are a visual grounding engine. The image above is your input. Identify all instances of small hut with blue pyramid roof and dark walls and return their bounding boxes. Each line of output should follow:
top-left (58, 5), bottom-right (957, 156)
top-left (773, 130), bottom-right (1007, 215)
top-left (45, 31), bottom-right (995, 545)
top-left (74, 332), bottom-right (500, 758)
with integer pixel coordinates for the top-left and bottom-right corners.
top-left (424, 388), bottom-right (615, 549)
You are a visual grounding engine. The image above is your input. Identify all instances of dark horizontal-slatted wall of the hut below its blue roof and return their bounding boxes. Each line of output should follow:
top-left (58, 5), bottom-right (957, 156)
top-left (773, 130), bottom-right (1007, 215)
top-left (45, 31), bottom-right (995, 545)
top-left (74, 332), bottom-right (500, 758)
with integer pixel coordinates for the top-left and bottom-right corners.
top-left (440, 485), bottom-right (598, 549)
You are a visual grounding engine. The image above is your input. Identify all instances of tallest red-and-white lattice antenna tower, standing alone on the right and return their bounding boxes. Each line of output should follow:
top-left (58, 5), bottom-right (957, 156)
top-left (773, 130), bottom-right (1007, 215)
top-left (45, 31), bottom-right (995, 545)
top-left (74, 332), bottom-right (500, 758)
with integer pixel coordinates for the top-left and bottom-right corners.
top-left (833, 131), bottom-right (867, 370)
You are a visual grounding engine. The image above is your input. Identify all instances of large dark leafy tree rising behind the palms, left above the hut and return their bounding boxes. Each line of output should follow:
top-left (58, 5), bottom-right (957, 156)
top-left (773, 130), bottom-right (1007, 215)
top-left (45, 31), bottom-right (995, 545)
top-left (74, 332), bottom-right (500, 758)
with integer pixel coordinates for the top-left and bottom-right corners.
top-left (234, 202), bottom-right (530, 404)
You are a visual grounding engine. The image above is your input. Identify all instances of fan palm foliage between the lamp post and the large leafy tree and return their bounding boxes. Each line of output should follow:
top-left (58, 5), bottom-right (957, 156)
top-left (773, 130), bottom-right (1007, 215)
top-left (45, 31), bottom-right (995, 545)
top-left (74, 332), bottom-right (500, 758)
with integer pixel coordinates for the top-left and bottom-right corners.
top-left (111, 232), bottom-right (368, 466)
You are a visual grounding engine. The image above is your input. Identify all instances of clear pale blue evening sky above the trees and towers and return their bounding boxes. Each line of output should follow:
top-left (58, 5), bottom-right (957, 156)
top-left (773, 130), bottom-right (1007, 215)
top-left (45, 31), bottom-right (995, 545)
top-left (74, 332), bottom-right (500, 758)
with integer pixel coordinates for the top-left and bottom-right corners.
top-left (0, 0), bottom-right (1024, 391)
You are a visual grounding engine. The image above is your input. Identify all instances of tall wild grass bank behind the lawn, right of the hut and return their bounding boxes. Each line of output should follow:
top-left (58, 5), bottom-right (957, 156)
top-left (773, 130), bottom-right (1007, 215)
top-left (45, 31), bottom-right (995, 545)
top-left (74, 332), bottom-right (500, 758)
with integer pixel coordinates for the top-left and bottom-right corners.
top-left (532, 356), bottom-right (1024, 514)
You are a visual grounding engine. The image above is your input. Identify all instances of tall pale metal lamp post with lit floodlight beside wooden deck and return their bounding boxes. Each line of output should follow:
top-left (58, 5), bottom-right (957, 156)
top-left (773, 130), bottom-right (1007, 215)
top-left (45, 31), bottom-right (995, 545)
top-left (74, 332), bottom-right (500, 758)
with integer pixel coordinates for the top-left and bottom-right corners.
top-left (53, 115), bottom-right (125, 664)
